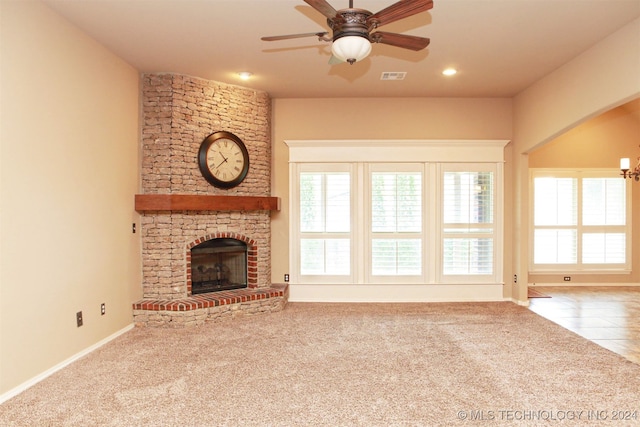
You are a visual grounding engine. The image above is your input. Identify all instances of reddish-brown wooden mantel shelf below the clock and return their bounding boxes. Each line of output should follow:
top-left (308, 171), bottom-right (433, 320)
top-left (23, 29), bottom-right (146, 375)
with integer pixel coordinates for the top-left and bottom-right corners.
top-left (135, 194), bottom-right (280, 212)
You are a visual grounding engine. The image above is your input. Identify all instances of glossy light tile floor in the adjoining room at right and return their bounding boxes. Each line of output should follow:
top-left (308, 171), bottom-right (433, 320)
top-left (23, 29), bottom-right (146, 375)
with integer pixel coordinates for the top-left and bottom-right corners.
top-left (529, 286), bottom-right (640, 364)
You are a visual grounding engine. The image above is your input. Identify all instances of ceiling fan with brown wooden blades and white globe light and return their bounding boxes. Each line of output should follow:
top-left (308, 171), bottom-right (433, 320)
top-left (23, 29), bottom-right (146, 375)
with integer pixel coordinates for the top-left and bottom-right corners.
top-left (262, 0), bottom-right (433, 65)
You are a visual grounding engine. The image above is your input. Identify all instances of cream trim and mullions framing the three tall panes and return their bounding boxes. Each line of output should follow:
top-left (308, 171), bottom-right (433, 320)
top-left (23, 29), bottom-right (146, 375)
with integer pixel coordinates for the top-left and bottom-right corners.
top-left (284, 140), bottom-right (509, 286)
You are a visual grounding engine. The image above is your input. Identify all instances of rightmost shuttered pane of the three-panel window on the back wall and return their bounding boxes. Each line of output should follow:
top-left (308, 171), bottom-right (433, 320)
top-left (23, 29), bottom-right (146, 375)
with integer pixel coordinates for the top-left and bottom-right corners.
top-left (442, 171), bottom-right (495, 276)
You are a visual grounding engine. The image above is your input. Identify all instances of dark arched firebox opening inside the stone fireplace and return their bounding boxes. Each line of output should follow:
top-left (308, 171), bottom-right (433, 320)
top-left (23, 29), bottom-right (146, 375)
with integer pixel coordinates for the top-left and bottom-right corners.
top-left (191, 238), bottom-right (247, 295)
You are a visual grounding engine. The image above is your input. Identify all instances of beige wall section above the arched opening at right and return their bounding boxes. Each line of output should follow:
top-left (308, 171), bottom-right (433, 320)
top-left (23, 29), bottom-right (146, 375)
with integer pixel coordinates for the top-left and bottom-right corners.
top-left (514, 18), bottom-right (640, 153)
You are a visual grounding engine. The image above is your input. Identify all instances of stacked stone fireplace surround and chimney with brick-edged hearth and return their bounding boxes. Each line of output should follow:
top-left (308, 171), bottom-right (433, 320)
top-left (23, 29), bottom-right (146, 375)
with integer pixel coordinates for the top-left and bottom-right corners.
top-left (134, 74), bottom-right (287, 325)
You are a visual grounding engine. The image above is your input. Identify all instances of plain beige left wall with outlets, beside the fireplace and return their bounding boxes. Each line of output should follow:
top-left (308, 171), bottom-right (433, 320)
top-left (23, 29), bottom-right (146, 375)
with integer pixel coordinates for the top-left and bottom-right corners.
top-left (0, 1), bottom-right (141, 396)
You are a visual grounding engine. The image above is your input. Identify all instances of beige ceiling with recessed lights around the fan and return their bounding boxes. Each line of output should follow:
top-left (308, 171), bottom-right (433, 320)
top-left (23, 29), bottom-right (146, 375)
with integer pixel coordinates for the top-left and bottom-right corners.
top-left (44, 0), bottom-right (640, 98)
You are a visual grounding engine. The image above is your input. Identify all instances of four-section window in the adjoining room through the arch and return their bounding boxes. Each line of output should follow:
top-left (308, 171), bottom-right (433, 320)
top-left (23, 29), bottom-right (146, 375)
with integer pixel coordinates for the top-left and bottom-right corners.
top-left (531, 170), bottom-right (630, 273)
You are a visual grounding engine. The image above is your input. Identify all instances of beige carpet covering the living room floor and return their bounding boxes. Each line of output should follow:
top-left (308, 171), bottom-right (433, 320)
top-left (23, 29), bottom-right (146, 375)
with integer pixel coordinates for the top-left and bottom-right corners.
top-left (0, 303), bottom-right (640, 426)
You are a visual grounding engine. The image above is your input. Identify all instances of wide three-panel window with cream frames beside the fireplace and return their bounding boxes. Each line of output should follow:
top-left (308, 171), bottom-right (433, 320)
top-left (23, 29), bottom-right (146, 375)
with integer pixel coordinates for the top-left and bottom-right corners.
top-left (290, 141), bottom-right (504, 289)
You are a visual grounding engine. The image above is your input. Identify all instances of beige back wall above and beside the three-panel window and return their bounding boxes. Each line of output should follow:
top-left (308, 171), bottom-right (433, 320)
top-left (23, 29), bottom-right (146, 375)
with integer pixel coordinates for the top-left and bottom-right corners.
top-left (271, 98), bottom-right (512, 296)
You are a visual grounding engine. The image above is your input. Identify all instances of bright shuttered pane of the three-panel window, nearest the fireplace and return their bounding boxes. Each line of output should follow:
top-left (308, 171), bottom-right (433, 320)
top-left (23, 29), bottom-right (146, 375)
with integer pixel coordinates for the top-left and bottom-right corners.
top-left (299, 172), bottom-right (351, 275)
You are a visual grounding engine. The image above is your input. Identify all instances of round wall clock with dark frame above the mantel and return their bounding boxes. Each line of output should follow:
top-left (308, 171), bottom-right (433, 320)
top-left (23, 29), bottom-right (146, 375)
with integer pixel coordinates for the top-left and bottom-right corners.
top-left (198, 131), bottom-right (249, 188)
